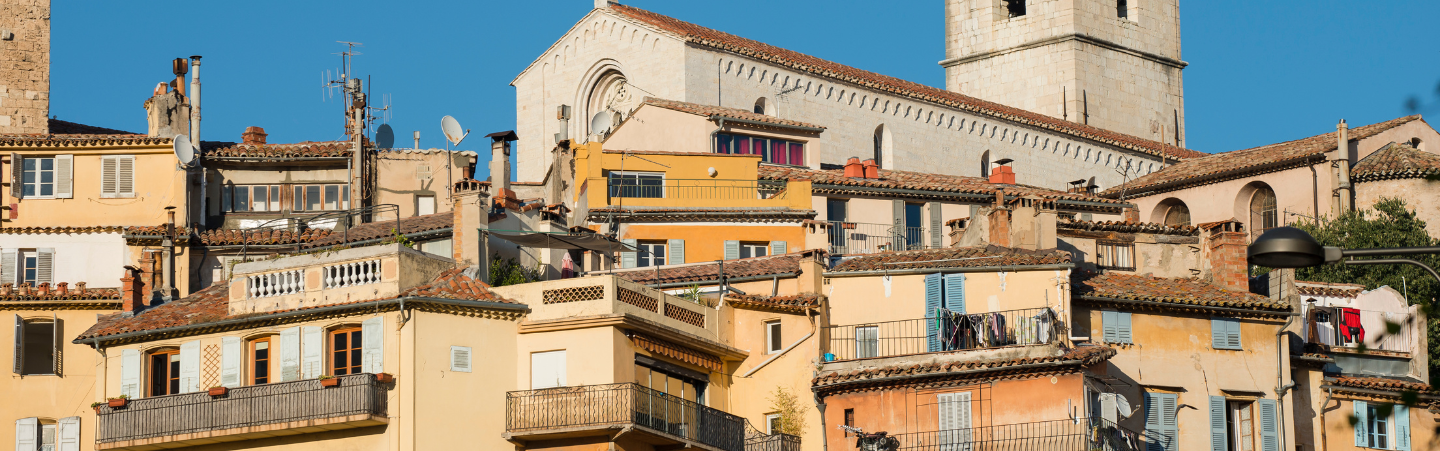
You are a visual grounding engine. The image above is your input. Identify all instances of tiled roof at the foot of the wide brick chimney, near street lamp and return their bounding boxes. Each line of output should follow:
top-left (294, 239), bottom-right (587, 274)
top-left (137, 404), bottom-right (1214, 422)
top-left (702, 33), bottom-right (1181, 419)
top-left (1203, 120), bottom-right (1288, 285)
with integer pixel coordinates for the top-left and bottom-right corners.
top-left (1071, 271), bottom-right (1290, 311)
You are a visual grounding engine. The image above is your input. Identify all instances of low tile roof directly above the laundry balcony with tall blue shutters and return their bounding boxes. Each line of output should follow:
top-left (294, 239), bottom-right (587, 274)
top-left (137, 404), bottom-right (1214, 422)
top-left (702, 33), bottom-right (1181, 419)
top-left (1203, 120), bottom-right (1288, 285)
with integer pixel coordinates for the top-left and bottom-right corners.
top-left (831, 245), bottom-right (1070, 272)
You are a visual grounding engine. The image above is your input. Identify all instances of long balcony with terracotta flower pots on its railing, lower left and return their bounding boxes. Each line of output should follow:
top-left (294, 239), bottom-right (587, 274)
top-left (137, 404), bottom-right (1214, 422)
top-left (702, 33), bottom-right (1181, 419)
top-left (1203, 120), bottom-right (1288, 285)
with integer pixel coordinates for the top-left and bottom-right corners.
top-left (95, 375), bottom-right (389, 450)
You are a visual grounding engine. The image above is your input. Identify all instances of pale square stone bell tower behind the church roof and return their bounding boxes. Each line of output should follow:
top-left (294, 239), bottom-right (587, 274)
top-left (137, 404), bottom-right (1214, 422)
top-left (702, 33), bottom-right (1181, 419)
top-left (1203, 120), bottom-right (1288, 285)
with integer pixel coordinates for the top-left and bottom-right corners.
top-left (940, 0), bottom-right (1185, 147)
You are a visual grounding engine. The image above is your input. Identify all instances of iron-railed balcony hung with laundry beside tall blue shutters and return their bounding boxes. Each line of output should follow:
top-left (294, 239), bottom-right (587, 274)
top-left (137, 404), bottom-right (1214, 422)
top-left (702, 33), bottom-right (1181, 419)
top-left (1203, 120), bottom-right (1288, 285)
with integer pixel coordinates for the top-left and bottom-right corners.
top-left (825, 308), bottom-right (1060, 362)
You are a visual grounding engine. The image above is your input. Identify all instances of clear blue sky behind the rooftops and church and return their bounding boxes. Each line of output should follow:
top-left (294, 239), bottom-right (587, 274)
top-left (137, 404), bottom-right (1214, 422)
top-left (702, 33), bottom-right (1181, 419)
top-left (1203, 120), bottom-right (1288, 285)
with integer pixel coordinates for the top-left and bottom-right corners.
top-left (50, 0), bottom-right (1440, 177)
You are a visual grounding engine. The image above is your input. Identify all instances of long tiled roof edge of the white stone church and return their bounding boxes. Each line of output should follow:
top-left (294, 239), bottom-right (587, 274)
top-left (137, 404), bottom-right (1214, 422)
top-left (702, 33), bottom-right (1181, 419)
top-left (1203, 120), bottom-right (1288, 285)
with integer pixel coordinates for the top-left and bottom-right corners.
top-left (608, 4), bottom-right (1202, 158)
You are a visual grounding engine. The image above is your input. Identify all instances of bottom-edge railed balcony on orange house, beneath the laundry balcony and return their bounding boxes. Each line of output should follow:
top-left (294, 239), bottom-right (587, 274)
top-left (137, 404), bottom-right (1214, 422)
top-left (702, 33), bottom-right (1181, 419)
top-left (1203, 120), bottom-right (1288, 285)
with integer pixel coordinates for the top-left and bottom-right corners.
top-left (850, 418), bottom-right (1164, 451)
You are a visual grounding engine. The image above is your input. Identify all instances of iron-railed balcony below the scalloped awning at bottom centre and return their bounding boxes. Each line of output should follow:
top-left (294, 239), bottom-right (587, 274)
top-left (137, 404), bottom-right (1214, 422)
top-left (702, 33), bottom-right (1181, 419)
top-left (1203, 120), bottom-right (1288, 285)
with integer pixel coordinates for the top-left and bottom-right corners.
top-left (505, 383), bottom-right (744, 451)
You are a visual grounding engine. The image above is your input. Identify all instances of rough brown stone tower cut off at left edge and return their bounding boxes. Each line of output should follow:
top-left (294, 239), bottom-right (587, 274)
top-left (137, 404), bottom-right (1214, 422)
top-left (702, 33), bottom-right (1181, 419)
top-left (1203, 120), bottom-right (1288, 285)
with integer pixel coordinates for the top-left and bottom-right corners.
top-left (0, 0), bottom-right (50, 134)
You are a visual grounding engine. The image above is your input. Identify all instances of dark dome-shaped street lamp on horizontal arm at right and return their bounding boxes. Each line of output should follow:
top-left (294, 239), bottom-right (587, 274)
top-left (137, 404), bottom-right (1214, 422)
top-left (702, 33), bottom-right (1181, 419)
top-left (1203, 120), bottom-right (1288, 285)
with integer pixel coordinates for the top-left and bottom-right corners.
top-left (1246, 228), bottom-right (1440, 281)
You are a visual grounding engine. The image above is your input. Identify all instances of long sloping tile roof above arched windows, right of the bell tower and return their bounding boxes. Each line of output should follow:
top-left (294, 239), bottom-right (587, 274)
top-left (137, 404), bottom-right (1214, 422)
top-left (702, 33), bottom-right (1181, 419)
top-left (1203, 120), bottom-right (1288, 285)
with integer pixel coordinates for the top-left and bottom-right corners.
top-left (1100, 115), bottom-right (1420, 197)
